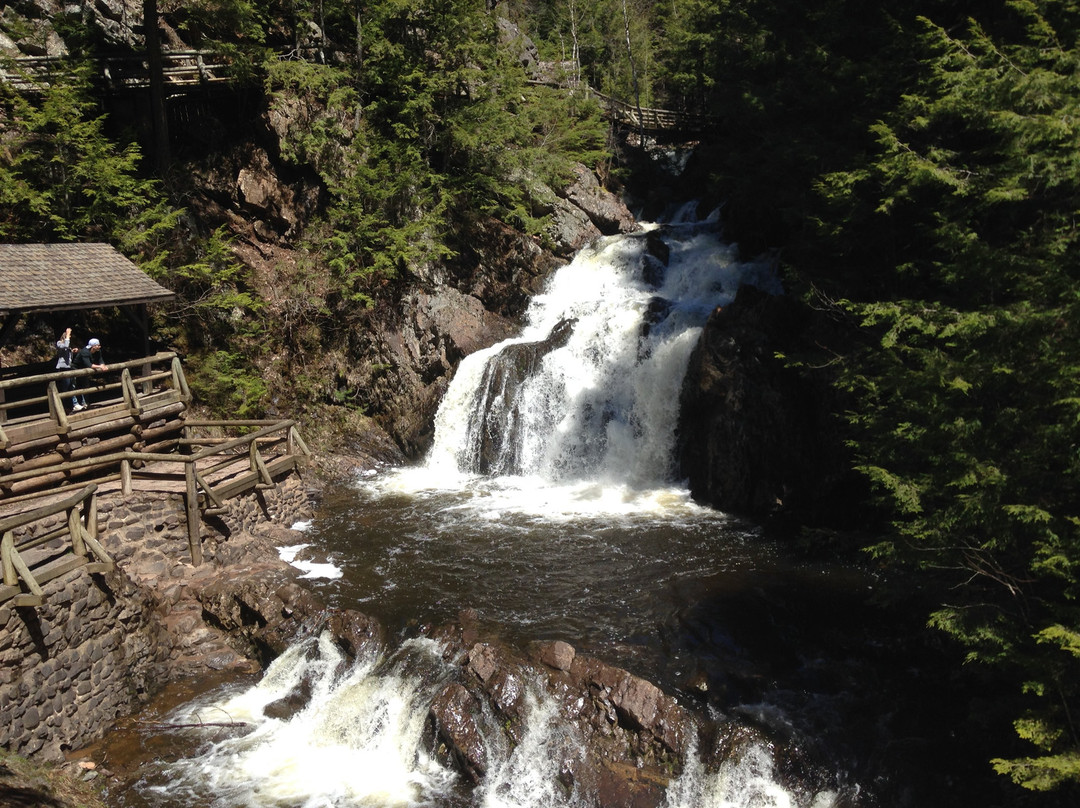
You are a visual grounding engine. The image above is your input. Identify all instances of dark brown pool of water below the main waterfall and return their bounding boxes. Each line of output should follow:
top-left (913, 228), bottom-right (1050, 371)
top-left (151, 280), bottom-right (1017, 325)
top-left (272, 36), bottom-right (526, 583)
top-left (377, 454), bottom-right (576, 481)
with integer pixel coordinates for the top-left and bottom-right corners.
top-left (92, 477), bottom-right (1054, 808)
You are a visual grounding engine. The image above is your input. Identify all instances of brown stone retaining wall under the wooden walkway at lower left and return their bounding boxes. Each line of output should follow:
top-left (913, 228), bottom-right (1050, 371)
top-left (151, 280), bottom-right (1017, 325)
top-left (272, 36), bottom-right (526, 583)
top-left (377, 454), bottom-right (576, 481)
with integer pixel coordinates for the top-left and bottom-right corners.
top-left (0, 475), bottom-right (311, 760)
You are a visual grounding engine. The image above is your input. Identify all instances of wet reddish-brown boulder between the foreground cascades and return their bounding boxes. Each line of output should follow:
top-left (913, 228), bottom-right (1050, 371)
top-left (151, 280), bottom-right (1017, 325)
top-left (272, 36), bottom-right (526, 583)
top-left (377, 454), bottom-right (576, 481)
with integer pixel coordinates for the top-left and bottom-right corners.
top-left (430, 615), bottom-right (700, 808)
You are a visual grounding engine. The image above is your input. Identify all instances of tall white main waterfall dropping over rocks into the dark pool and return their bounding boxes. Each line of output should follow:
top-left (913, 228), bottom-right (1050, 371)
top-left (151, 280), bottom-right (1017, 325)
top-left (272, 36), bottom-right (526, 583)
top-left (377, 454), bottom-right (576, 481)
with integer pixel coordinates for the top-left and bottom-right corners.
top-left (419, 205), bottom-right (779, 489)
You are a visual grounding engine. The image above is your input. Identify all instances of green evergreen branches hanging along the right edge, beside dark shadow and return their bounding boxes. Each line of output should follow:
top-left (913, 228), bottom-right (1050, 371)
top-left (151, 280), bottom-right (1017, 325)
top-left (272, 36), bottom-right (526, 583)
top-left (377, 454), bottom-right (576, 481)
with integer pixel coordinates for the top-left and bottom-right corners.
top-left (818, 0), bottom-right (1080, 790)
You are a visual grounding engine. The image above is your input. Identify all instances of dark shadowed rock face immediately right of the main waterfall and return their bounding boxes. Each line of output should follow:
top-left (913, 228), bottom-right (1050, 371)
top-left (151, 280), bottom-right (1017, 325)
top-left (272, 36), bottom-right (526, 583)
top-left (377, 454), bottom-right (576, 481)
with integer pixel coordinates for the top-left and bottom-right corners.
top-left (679, 286), bottom-right (859, 526)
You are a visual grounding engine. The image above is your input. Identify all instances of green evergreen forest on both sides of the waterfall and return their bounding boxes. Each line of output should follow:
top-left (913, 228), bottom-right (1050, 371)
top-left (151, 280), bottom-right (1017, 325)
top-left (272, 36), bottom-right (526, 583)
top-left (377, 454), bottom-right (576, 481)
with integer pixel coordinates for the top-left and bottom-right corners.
top-left (0, 0), bottom-right (1080, 791)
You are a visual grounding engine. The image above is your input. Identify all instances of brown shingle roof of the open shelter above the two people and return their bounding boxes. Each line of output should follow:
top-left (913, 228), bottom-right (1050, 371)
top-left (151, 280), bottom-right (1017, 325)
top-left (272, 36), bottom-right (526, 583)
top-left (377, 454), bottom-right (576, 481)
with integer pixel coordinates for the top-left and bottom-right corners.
top-left (0, 244), bottom-right (174, 313)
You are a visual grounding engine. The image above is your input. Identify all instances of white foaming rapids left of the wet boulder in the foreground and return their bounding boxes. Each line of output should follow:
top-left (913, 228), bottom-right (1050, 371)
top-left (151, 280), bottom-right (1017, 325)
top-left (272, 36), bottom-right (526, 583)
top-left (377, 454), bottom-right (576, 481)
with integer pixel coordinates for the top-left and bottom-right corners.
top-left (149, 635), bottom-right (456, 808)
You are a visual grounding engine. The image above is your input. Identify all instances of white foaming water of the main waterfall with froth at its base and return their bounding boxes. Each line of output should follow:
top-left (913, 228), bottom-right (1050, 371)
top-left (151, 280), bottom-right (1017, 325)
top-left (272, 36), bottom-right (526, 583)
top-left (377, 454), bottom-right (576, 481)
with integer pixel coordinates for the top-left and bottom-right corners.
top-left (375, 207), bottom-right (781, 522)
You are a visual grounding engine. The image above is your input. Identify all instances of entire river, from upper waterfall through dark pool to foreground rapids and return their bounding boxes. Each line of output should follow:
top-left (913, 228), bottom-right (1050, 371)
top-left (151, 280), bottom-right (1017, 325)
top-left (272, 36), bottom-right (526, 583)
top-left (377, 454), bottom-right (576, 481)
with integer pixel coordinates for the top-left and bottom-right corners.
top-left (92, 214), bottom-right (1002, 808)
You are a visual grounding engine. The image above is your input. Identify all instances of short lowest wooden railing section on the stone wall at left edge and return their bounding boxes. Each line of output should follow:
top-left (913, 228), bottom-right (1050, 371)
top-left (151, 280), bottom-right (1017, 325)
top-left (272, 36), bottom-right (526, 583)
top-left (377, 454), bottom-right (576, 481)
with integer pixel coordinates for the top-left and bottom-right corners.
top-left (0, 484), bottom-right (116, 606)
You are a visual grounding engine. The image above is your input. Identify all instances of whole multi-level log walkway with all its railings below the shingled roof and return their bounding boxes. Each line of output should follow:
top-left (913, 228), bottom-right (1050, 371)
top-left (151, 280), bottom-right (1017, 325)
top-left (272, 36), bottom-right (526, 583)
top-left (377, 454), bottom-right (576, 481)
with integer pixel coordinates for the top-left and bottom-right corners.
top-left (0, 352), bottom-right (309, 606)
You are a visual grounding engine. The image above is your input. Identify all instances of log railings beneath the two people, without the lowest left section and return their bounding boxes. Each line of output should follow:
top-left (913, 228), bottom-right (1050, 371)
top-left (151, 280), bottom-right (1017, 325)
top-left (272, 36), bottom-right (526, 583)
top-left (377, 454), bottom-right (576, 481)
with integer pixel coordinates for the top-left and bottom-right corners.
top-left (0, 352), bottom-right (310, 565)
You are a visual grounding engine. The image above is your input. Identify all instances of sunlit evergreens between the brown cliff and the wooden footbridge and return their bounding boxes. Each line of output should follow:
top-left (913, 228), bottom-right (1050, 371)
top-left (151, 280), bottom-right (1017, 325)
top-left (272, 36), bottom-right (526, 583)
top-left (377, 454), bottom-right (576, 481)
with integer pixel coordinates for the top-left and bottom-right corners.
top-left (267, 0), bottom-right (606, 305)
